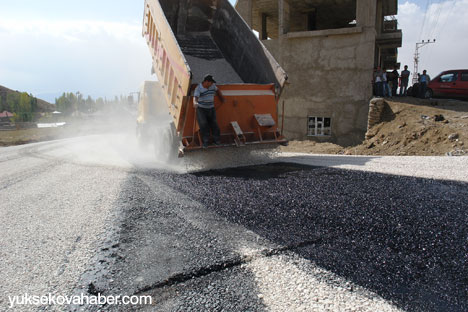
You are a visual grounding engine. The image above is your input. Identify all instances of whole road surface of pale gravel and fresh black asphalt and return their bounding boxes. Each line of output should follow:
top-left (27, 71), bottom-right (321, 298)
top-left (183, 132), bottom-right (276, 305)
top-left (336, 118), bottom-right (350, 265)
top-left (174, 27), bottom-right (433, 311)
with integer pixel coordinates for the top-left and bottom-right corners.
top-left (0, 136), bottom-right (468, 311)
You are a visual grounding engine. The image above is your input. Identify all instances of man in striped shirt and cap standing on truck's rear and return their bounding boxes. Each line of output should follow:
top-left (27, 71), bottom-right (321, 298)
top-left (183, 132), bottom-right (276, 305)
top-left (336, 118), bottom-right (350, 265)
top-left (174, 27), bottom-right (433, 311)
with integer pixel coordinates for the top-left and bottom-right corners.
top-left (193, 75), bottom-right (224, 148)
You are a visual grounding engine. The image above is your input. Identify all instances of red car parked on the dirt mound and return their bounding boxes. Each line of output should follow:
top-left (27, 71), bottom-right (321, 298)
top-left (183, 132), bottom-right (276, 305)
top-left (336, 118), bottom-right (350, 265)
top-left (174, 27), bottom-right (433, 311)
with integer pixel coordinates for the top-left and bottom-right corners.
top-left (425, 69), bottom-right (468, 99)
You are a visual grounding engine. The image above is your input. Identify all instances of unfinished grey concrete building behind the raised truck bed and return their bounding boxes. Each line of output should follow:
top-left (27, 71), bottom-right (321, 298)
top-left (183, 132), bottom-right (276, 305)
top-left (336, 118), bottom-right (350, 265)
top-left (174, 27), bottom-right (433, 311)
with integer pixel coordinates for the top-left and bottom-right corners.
top-left (236, 0), bottom-right (402, 145)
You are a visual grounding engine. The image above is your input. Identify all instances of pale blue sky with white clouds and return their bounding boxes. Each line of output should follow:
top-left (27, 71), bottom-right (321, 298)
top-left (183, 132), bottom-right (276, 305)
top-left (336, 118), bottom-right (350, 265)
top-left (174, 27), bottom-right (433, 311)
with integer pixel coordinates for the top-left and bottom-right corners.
top-left (0, 0), bottom-right (468, 102)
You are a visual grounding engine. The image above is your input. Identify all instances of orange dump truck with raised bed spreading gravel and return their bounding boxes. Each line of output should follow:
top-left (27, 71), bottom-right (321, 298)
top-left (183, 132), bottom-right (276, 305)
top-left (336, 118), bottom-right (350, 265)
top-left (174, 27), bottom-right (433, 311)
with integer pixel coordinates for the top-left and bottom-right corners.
top-left (137, 0), bottom-right (287, 158)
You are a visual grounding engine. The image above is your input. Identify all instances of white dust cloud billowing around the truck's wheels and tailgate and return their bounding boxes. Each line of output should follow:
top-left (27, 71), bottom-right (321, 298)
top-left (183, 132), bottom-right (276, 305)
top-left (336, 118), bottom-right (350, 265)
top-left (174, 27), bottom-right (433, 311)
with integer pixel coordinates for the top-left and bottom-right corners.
top-left (41, 85), bottom-right (275, 173)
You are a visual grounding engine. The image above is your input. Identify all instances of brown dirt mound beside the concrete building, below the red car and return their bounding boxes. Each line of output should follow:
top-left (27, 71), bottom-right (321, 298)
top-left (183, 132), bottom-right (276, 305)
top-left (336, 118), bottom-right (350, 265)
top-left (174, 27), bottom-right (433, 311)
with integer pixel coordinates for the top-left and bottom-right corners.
top-left (281, 97), bottom-right (468, 156)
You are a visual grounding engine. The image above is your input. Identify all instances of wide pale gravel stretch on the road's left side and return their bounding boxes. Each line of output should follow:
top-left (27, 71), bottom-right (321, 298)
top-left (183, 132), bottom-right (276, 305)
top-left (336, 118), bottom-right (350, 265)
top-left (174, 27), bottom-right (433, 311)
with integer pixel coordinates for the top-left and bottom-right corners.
top-left (0, 143), bottom-right (126, 311)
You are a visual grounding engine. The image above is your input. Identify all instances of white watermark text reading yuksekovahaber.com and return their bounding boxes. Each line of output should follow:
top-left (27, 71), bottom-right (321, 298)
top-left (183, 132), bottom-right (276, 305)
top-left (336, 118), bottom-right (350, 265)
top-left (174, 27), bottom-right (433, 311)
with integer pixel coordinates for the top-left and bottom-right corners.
top-left (8, 293), bottom-right (153, 309)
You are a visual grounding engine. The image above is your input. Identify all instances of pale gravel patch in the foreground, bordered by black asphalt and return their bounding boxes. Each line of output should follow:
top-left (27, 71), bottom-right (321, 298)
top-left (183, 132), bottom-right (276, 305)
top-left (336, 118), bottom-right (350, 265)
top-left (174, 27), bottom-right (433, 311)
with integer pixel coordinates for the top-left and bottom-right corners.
top-left (243, 253), bottom-right (402, 312)
